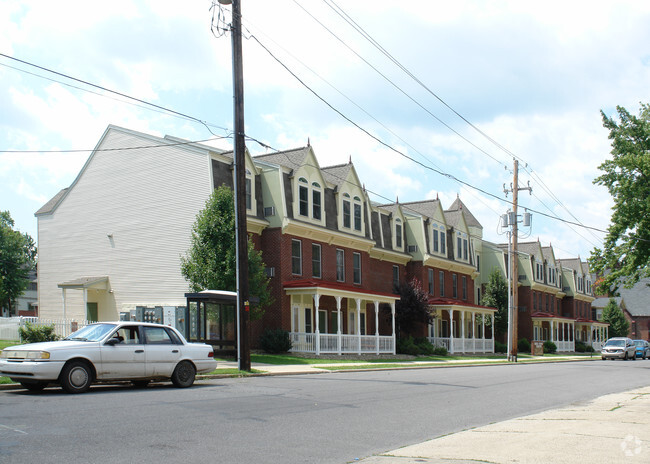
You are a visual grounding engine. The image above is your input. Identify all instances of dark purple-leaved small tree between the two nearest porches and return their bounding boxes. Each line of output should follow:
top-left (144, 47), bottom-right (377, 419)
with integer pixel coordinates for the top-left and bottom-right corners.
top-left (395, 278), bottom-right (434, 338)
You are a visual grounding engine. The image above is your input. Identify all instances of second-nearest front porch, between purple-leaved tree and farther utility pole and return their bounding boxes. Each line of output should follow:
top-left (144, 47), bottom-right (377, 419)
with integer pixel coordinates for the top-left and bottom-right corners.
top-left (428, 298), bottom-right (496, 353)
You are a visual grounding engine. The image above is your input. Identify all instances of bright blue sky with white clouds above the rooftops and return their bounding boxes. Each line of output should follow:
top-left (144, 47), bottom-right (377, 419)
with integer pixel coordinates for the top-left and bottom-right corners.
top-left (0, 0), bottom-right (650, 259)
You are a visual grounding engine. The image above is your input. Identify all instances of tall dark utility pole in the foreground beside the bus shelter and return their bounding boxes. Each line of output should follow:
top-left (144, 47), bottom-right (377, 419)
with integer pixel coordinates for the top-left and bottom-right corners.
top-left (224, 0), bottom-right (251, 371)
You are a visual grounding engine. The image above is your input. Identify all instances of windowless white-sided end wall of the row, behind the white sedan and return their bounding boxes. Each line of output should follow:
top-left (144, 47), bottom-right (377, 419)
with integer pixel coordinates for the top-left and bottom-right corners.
top-left (36, 126), bottom-right (215, 320)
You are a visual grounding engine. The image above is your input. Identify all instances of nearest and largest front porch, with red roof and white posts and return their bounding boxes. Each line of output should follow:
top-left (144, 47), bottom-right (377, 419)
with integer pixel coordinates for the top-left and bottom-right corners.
top-left (284, 281), bottom-right (399, 356)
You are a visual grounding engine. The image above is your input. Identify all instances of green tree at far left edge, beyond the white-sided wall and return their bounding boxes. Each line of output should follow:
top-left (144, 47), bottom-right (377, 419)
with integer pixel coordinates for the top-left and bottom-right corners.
top-left (0, 211), bottom-right (36, 314)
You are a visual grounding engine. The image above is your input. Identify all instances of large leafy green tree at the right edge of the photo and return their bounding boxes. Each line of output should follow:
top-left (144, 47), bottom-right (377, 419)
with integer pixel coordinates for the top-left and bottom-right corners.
top-left (590, 103), bottom-right (650, 294)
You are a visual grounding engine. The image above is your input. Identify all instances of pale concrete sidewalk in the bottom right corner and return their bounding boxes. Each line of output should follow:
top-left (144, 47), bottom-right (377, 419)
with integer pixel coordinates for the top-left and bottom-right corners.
top-left (359, 387), bottom-right (650, 464)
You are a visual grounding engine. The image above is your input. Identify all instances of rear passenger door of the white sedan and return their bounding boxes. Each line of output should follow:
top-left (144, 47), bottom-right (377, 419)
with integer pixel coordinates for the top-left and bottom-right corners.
top-left (142, 325), bottom-right (182, 377)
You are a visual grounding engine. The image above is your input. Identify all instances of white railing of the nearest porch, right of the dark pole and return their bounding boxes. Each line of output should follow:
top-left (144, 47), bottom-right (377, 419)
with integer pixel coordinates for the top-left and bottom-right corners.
top-left (290, 332), bottom-right (395, 354)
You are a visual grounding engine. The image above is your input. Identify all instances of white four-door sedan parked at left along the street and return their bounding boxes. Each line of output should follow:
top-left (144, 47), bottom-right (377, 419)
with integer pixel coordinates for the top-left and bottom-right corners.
top-left (0, 322), bottom-right (217, 393)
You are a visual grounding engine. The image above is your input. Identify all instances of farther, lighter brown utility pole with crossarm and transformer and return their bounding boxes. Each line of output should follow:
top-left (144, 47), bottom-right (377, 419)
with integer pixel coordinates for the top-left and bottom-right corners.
top-left (504, 159), bottom-right (533, 362)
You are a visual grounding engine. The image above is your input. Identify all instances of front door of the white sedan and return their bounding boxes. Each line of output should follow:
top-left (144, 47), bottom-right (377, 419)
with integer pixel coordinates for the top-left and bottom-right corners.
top-left (97, 325), bottom-right (145, 379)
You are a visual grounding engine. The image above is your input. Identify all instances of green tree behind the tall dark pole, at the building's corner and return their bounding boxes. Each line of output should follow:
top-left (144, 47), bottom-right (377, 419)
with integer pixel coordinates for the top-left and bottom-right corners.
top-left (181, 186), bottom-right (272, 319)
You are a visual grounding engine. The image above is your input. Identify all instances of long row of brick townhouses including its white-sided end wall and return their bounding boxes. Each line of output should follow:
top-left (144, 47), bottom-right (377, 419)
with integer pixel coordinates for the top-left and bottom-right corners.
top-left (36, 126), bottom-right (591, 354)
